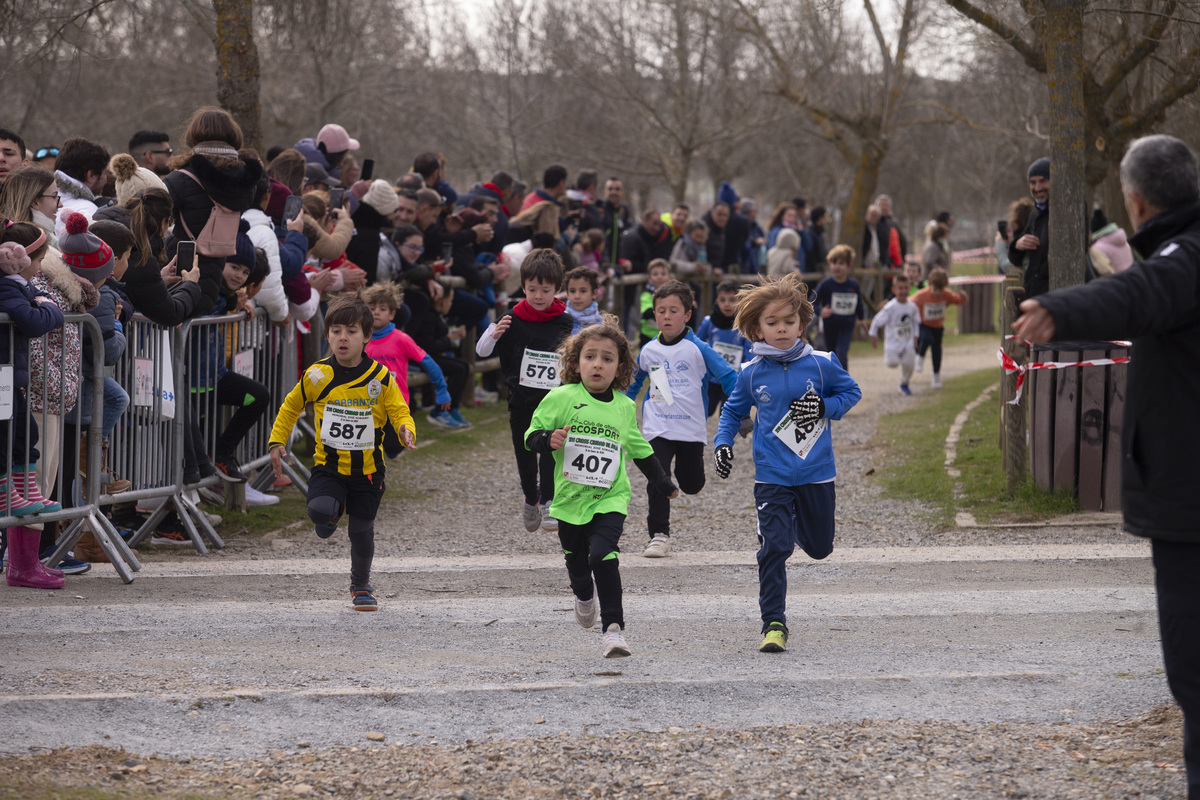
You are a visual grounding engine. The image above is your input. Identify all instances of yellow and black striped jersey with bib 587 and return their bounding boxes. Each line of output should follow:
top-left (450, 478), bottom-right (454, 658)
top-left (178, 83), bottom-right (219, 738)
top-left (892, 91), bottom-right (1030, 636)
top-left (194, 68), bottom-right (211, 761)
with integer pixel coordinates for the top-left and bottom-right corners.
top-left (270, 356), bottom-right (416, 476)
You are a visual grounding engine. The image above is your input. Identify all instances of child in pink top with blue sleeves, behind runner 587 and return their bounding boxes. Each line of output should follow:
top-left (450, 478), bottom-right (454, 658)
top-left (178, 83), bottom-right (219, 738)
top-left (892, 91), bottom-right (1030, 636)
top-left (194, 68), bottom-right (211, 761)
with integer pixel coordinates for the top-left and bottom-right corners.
top-left (359, 281), bottom-right (458, 438)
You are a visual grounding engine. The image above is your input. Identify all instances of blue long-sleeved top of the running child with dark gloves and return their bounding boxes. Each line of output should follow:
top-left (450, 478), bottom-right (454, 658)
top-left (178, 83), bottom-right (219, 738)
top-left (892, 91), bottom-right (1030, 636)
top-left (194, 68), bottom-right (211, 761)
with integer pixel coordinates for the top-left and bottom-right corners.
top-left (713, 344), bottom-right (863, 486)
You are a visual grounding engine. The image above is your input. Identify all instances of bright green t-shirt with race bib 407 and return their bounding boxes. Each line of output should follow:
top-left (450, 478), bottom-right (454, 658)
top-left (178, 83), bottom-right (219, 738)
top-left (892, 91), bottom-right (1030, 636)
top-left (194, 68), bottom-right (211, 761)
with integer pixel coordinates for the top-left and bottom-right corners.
top-left (524, 384), bottom-right (654, 525)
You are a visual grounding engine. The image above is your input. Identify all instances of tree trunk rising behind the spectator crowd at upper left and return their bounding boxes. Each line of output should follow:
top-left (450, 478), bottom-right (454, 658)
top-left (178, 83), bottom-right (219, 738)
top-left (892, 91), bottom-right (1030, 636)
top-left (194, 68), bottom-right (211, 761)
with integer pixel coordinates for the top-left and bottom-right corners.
top-left (212, 0), bottom-right (264, 154)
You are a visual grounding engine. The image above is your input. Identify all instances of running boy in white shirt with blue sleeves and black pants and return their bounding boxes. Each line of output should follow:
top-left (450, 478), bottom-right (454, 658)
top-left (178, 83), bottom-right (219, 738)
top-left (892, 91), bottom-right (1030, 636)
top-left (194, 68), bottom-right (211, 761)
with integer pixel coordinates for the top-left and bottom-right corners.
top-left (626, 281), bottom-right (738, 558)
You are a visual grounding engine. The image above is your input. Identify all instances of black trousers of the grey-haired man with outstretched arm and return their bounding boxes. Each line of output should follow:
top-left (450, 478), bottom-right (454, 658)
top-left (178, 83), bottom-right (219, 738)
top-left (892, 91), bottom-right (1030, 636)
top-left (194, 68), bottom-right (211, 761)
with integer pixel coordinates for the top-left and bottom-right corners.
top-left (1153, 540), bottom-right (1200, 800)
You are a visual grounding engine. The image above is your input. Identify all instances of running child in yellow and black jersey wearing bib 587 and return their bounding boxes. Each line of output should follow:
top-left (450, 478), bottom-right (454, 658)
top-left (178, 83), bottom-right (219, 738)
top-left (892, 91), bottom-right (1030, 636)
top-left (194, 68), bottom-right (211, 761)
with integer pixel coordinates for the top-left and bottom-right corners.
top-left (270, 297), bottom-right (416, 612)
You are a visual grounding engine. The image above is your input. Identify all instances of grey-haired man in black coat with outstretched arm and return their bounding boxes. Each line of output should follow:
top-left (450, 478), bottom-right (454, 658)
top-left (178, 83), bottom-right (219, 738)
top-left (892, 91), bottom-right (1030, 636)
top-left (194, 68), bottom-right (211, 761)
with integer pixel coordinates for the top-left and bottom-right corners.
top-left (1013, 136), bottom-right (1200, 800)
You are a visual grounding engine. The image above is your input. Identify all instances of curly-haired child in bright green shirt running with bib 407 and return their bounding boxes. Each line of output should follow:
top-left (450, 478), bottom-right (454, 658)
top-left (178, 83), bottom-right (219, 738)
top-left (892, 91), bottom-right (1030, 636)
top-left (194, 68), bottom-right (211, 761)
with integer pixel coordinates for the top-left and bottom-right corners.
top-left (526, 315), bottom-right (679, 658)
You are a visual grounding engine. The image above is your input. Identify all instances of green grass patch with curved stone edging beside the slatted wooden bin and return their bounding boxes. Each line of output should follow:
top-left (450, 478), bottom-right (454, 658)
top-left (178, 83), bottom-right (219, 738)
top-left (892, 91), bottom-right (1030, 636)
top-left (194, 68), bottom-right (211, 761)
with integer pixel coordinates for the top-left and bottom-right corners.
top-left (864, 362), bottom-right (1078, 527)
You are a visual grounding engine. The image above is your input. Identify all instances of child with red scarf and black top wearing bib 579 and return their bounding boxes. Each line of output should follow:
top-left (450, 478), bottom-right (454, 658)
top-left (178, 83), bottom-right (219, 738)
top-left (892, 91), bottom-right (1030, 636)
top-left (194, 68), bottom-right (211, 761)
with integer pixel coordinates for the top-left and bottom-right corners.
top-left (475, 248), bottom-right (572, 533)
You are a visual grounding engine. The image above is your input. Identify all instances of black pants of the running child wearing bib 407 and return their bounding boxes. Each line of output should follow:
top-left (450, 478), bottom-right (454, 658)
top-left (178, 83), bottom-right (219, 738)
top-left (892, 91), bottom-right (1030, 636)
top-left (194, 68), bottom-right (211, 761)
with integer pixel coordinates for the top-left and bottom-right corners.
top-left (558, 511), bottom-right (625, 630)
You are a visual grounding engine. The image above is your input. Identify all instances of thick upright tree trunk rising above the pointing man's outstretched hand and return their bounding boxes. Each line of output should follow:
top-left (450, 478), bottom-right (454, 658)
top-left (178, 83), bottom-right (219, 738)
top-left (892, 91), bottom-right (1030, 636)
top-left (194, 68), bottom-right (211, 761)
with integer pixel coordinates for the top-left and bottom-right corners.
top-left (1045, 0), bottom-right (1091, 290)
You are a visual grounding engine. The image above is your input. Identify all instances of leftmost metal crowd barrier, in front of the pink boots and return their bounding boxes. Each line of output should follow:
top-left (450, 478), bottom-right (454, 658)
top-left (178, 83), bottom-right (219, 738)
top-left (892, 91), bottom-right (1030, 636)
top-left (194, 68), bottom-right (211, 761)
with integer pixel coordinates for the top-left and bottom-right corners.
top-left (0, 314), bottom-right (142, 583)
